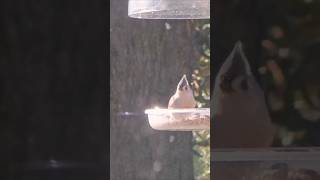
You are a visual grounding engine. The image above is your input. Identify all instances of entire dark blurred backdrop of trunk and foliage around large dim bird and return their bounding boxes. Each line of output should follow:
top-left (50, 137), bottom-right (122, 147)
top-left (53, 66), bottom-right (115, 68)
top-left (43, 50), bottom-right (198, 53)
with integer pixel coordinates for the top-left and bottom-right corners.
top-left (211, 0), bottom-right (320, 146)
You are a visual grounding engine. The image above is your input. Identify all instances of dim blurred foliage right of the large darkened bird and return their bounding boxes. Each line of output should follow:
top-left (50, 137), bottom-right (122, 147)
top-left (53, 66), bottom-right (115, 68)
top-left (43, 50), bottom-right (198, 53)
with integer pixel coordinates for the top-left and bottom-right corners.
top-left (258, 0), bottom-right (320, 146)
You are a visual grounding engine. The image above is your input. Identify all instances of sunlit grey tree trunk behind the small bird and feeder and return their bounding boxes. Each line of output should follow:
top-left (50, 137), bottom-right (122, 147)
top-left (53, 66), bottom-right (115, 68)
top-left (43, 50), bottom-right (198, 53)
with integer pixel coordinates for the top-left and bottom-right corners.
top-left (110, 0), bottom-right (198, 180)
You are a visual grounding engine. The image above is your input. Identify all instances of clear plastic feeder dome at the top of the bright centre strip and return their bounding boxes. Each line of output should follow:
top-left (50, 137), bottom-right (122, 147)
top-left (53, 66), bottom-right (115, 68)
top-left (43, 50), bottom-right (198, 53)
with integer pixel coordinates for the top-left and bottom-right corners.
top-left (128, 0), bottom-right (210, 19)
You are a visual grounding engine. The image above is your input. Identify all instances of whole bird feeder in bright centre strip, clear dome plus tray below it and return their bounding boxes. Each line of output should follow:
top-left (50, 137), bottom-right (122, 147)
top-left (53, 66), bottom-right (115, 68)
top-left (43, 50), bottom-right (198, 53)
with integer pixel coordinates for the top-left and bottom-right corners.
top-left (128, 0), bottom-right (210, 131)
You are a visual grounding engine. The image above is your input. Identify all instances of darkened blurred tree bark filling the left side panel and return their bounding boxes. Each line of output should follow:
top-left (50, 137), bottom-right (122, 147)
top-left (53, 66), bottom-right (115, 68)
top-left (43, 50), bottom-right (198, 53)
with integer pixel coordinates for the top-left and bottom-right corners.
top-left (0, 0), bottom-right (107, 180)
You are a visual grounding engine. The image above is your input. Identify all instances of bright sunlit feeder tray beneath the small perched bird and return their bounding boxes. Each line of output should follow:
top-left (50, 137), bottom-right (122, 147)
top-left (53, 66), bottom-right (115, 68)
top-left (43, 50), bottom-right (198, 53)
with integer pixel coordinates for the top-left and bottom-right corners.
top-left (145, 108), bottom-right (210, 131)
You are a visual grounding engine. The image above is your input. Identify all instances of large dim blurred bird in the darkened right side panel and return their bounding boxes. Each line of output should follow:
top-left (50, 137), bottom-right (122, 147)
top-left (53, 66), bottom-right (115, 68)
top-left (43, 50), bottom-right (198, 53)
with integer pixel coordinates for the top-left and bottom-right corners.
top-left (211, 42), bottom-right (274, 148)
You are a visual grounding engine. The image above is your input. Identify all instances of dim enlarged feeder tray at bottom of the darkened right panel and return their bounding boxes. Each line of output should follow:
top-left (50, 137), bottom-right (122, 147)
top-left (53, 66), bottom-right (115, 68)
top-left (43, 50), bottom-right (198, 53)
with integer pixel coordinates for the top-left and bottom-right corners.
top-left (210, 147), bottom-right (320, 180)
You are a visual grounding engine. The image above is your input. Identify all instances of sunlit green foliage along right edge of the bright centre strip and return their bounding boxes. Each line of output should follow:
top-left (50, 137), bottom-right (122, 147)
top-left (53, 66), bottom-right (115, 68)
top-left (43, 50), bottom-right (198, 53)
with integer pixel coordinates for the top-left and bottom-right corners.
top-left (191, 20), bottom-right (210, 180)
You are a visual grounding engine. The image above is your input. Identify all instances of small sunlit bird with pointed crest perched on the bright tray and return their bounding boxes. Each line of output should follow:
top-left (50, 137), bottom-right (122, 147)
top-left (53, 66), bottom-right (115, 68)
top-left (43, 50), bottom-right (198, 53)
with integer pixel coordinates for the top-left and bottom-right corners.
top-left (168, 74), bottom-right (197, 109)
